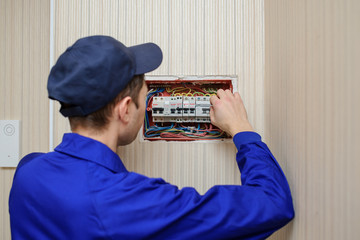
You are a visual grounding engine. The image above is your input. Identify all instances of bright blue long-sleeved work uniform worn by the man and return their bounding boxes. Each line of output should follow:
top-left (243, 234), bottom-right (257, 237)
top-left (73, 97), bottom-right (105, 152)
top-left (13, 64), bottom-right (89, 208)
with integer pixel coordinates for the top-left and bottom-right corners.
top-left (9, 132), bottom-right (294, 240)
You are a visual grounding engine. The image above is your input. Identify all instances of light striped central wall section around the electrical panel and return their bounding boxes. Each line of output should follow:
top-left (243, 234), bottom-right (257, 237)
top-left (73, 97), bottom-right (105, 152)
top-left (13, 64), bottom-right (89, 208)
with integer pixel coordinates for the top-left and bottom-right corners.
top-left (54, 0), bottom-right (264, 193)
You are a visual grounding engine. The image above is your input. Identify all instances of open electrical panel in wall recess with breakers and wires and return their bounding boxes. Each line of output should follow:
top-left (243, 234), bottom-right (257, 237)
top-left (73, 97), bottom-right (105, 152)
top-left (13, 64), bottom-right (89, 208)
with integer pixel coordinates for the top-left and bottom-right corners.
top-left (143, 77), bottom-right (234, 141)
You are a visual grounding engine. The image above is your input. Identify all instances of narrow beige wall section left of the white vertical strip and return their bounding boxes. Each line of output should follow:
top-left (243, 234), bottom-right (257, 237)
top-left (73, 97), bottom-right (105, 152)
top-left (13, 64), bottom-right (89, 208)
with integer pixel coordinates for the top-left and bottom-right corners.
top-left (0, 0), bottom-right (50, 239)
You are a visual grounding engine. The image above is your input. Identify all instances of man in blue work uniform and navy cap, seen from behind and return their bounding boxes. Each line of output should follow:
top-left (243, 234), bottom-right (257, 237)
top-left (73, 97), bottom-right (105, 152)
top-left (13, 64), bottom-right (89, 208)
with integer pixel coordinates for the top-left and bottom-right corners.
top-left (9, 36), bottom-right (294, 239)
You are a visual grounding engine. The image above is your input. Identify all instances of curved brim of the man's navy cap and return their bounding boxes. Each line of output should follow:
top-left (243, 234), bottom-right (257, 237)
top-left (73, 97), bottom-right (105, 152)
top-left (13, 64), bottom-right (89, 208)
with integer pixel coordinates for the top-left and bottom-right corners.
top-left (128, 43), bottom-right (163, 75)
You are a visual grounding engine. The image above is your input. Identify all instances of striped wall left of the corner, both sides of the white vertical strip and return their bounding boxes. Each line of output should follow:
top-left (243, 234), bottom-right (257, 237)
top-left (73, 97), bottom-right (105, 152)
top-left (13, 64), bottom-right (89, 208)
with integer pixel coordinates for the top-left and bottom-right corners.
top-left (0, 0), bottom-right (264, 239)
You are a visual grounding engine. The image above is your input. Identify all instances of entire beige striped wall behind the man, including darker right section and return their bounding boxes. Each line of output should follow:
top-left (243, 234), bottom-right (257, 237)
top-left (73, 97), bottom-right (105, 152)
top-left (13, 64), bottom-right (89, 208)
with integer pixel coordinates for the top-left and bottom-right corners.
top-left (0, 0), bottom-right (360, 240)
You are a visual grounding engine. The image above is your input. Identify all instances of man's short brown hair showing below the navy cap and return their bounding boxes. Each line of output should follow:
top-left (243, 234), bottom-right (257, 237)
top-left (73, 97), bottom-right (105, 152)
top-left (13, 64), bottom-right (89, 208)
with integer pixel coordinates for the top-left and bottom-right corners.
top-left (69, 74), bottom-right (145, 131)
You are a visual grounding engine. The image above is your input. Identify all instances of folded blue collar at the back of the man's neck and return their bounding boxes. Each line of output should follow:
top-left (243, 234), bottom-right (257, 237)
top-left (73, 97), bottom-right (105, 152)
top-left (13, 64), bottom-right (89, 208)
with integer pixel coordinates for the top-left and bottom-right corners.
top-left (55, 133), bottom-right (127, 172)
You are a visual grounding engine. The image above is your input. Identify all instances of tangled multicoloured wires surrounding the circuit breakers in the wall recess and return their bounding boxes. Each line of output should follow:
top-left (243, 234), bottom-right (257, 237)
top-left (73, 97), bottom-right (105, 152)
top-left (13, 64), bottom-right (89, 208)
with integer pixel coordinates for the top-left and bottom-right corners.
top-left (144, 86), bottom-right (227, 140)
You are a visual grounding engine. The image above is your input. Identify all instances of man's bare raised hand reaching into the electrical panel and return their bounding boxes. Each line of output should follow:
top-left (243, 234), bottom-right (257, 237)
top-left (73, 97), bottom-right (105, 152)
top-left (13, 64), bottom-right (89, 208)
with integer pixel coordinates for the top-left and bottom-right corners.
top-left (210, 89), bottom-right (254, 136)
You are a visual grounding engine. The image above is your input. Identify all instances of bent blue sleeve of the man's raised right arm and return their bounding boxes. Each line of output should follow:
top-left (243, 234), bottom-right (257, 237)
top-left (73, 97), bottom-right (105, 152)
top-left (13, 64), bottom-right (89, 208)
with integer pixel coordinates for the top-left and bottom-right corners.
top-left (97, 132), bottom-right (294, 239)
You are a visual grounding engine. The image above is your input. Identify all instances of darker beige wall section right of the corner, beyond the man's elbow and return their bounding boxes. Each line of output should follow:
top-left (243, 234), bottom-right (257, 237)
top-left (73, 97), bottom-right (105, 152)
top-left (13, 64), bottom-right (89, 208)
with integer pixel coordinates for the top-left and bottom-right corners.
top-left (265, 0), bottom-right (360, 240)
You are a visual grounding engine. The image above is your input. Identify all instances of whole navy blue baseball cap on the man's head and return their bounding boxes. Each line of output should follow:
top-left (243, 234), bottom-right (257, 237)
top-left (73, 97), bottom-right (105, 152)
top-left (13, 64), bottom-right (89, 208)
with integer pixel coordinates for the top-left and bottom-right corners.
top-left (47, 36), bottom-right (163, 117)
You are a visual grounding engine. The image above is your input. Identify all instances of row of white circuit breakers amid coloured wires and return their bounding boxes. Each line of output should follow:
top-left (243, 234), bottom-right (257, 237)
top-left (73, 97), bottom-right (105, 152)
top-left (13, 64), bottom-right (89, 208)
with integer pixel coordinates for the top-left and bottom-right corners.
top-left (152, 96), bottom-right (211, 123)
